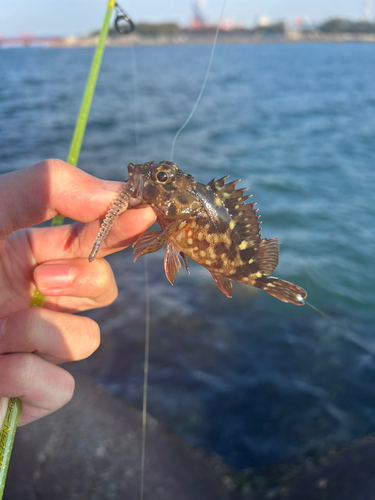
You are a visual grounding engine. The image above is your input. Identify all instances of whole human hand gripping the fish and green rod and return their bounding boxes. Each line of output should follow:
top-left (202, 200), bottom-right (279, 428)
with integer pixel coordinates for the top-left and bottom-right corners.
top-left (0, 160), bottom-right (155, 425)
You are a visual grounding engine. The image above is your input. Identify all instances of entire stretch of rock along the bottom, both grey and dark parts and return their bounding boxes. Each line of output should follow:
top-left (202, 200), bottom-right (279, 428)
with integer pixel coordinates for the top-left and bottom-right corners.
top-left (4, 367), bottom-right (375, 500)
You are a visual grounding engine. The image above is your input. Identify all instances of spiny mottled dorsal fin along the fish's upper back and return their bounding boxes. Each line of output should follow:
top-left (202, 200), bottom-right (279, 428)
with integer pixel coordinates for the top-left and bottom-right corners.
top-left (208, 175), bottom-right (260, 243)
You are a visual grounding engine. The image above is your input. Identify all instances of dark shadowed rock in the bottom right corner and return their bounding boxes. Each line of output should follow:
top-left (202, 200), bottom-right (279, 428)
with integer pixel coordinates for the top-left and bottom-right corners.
top-left (235, 436), bottom-right (375, 500)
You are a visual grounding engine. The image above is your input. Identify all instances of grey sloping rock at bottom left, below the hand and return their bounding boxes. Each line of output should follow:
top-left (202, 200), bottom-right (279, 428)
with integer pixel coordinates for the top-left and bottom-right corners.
top-left (4, 364), bottom-right (232, 500)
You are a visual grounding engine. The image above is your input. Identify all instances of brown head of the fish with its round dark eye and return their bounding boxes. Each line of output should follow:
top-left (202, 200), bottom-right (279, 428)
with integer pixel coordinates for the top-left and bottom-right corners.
top-left (128, 161), bottom-right (200, 220)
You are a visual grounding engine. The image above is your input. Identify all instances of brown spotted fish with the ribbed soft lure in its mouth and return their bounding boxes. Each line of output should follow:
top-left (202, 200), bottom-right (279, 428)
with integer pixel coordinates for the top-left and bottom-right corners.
top-left (89, 161), bottom-right (307, 305)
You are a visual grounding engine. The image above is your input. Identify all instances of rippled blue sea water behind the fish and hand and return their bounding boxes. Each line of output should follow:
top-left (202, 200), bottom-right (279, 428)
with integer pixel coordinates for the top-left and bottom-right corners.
top-left (0, 43), bottom-right (375, 467)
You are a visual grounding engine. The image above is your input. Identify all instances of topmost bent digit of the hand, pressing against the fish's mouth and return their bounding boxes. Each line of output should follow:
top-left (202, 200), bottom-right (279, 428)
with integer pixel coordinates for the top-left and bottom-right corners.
top-left (0, 160), bottom-right (128, 241)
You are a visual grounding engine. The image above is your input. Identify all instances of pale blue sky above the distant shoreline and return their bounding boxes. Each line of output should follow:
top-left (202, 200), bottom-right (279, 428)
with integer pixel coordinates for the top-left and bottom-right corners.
top-left (0, 0), bottom-right (375, 36)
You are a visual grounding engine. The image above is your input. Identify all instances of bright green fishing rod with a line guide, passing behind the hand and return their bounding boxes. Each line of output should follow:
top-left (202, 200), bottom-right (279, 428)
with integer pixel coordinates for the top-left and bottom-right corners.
top-left (0, 0), bottom-right (134, 500)
